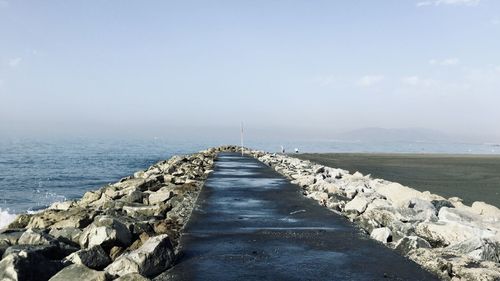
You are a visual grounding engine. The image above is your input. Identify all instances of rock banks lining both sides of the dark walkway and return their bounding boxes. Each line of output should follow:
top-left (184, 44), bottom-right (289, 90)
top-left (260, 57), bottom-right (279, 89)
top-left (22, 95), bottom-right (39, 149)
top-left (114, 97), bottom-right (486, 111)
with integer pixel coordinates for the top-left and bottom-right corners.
top-left (0, 146), bottom-right (500, 281)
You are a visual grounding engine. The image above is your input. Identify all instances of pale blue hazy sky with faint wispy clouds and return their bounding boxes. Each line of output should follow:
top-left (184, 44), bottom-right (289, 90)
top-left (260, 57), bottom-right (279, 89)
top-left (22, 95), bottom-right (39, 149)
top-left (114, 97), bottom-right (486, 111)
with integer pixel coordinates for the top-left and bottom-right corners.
top-left (0, 0), bottom-right (500, 139)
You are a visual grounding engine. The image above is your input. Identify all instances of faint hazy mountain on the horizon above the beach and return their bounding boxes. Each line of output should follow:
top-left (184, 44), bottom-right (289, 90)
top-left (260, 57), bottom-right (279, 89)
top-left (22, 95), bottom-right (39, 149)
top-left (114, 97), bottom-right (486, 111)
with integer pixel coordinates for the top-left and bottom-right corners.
top-left (337, 128), bottom-right (456, 142)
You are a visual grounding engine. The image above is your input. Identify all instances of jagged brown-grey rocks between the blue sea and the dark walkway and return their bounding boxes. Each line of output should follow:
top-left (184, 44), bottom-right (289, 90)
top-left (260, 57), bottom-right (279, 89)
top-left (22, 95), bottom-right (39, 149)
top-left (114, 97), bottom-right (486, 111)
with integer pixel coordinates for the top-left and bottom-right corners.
top-left (0, 149), bottom-right (219, 281)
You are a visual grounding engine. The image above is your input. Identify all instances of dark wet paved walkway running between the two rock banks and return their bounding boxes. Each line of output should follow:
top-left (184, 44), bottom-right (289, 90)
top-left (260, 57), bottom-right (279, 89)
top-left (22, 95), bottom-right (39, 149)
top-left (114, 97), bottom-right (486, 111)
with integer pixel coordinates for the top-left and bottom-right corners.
top-left (155, 153), bottom-right (438, 280)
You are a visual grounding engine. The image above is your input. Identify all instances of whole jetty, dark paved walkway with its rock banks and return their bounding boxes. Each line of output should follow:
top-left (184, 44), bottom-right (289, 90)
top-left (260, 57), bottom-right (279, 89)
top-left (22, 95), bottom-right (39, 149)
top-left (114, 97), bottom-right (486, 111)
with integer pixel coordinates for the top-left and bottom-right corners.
top-left (0, 146), bottom-right (500, 281)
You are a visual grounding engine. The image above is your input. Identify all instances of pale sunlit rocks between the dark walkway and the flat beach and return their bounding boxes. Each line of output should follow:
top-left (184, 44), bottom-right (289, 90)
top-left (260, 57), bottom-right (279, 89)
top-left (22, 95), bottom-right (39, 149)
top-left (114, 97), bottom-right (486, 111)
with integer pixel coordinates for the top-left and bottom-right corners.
top-left (239, 148), bottom-right (500, 280)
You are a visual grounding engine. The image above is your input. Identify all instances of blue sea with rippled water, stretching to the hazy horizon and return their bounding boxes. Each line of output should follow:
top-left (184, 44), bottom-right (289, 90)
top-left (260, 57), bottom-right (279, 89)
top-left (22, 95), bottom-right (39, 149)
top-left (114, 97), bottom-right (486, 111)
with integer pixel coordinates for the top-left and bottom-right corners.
top-left (0, 138), bottom-right (500, 229)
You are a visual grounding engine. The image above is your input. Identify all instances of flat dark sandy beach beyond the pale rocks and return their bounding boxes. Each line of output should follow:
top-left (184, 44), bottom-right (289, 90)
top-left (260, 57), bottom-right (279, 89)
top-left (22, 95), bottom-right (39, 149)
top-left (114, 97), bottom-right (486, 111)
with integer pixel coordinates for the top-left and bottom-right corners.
top-left (295, 153), bottom-right (500, 207)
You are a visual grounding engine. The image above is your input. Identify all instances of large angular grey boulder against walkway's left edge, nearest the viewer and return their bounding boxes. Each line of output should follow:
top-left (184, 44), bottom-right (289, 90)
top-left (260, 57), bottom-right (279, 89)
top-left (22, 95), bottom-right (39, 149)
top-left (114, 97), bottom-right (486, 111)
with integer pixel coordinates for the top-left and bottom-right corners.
top-left (106, 234), bottom-right (174, 277)
